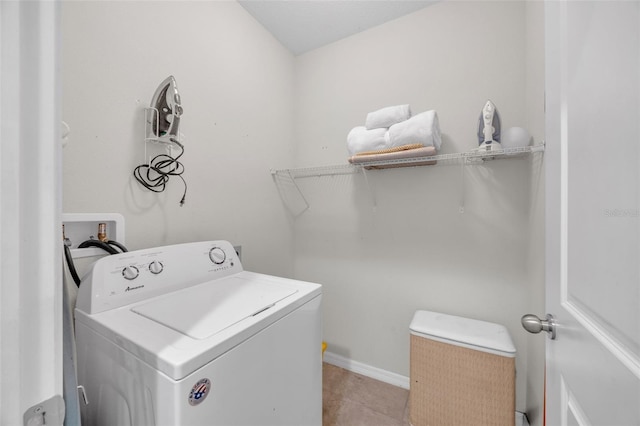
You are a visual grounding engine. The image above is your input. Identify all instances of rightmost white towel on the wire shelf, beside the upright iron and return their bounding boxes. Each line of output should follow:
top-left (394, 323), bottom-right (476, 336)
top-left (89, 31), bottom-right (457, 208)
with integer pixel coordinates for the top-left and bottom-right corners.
top-left (389, 110), bottom-right (442, 150)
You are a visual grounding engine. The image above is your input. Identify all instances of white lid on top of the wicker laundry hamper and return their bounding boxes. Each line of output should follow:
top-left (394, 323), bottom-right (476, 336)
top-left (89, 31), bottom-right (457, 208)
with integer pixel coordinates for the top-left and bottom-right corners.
top-left (409, 311), bottom-right (516, 357)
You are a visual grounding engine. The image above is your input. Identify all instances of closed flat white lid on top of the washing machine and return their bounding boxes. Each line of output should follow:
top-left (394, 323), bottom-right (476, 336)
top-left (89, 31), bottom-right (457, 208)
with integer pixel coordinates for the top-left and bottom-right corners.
top-left (131, 276), bottom-right (297, 339)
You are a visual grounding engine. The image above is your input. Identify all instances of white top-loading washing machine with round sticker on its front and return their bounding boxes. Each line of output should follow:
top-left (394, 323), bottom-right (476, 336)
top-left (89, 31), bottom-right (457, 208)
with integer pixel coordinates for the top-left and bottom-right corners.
top-left (75, 241), bottom-right (322, 426)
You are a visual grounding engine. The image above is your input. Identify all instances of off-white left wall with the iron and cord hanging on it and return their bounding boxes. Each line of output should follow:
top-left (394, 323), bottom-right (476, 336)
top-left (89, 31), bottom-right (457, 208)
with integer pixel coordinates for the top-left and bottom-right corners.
top-left (62, 1), bottom-right (294, 275)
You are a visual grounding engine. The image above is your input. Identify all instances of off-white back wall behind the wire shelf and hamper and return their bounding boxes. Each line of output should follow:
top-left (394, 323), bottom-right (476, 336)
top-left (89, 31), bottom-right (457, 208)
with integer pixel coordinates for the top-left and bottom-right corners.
top-left (295, 2), bottom-right (535, 411)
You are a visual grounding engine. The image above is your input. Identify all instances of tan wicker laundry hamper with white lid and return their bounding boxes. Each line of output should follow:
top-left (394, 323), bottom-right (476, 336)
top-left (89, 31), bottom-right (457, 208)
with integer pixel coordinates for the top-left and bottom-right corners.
top-left (409, 311), bottom-right (516, 426)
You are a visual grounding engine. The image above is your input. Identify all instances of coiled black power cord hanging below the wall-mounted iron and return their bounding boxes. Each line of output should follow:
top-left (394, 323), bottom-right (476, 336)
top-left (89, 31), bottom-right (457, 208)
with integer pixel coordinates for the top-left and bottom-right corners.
top-left (133, 139), bottom-right (187, 207)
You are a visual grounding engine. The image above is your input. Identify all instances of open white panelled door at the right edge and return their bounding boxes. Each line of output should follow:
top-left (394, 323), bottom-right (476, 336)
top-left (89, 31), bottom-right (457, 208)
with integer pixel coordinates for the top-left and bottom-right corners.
top-left (545, 1), bottom-right (640, 426)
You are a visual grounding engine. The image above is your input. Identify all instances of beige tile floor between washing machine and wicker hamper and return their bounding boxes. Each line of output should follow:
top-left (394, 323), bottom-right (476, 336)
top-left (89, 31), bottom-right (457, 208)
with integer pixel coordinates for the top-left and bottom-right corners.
top-left (322, 363), bottom-right (409, 426)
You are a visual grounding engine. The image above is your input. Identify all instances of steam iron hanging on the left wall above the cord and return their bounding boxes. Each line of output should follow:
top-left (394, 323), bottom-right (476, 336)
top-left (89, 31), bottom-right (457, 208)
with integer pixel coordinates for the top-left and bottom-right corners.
top-left (151, 75), bottom-right (183, 142)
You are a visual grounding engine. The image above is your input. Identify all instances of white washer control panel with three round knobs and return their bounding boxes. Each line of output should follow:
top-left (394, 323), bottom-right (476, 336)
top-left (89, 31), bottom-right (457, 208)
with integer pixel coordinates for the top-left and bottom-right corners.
top-left (76, 241), bottom-right (243, 314)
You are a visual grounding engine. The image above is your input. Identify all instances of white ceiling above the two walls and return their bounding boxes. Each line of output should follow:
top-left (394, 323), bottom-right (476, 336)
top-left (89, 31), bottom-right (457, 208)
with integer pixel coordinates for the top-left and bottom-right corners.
top-left (238, 0), bottom-right (437, 55)
